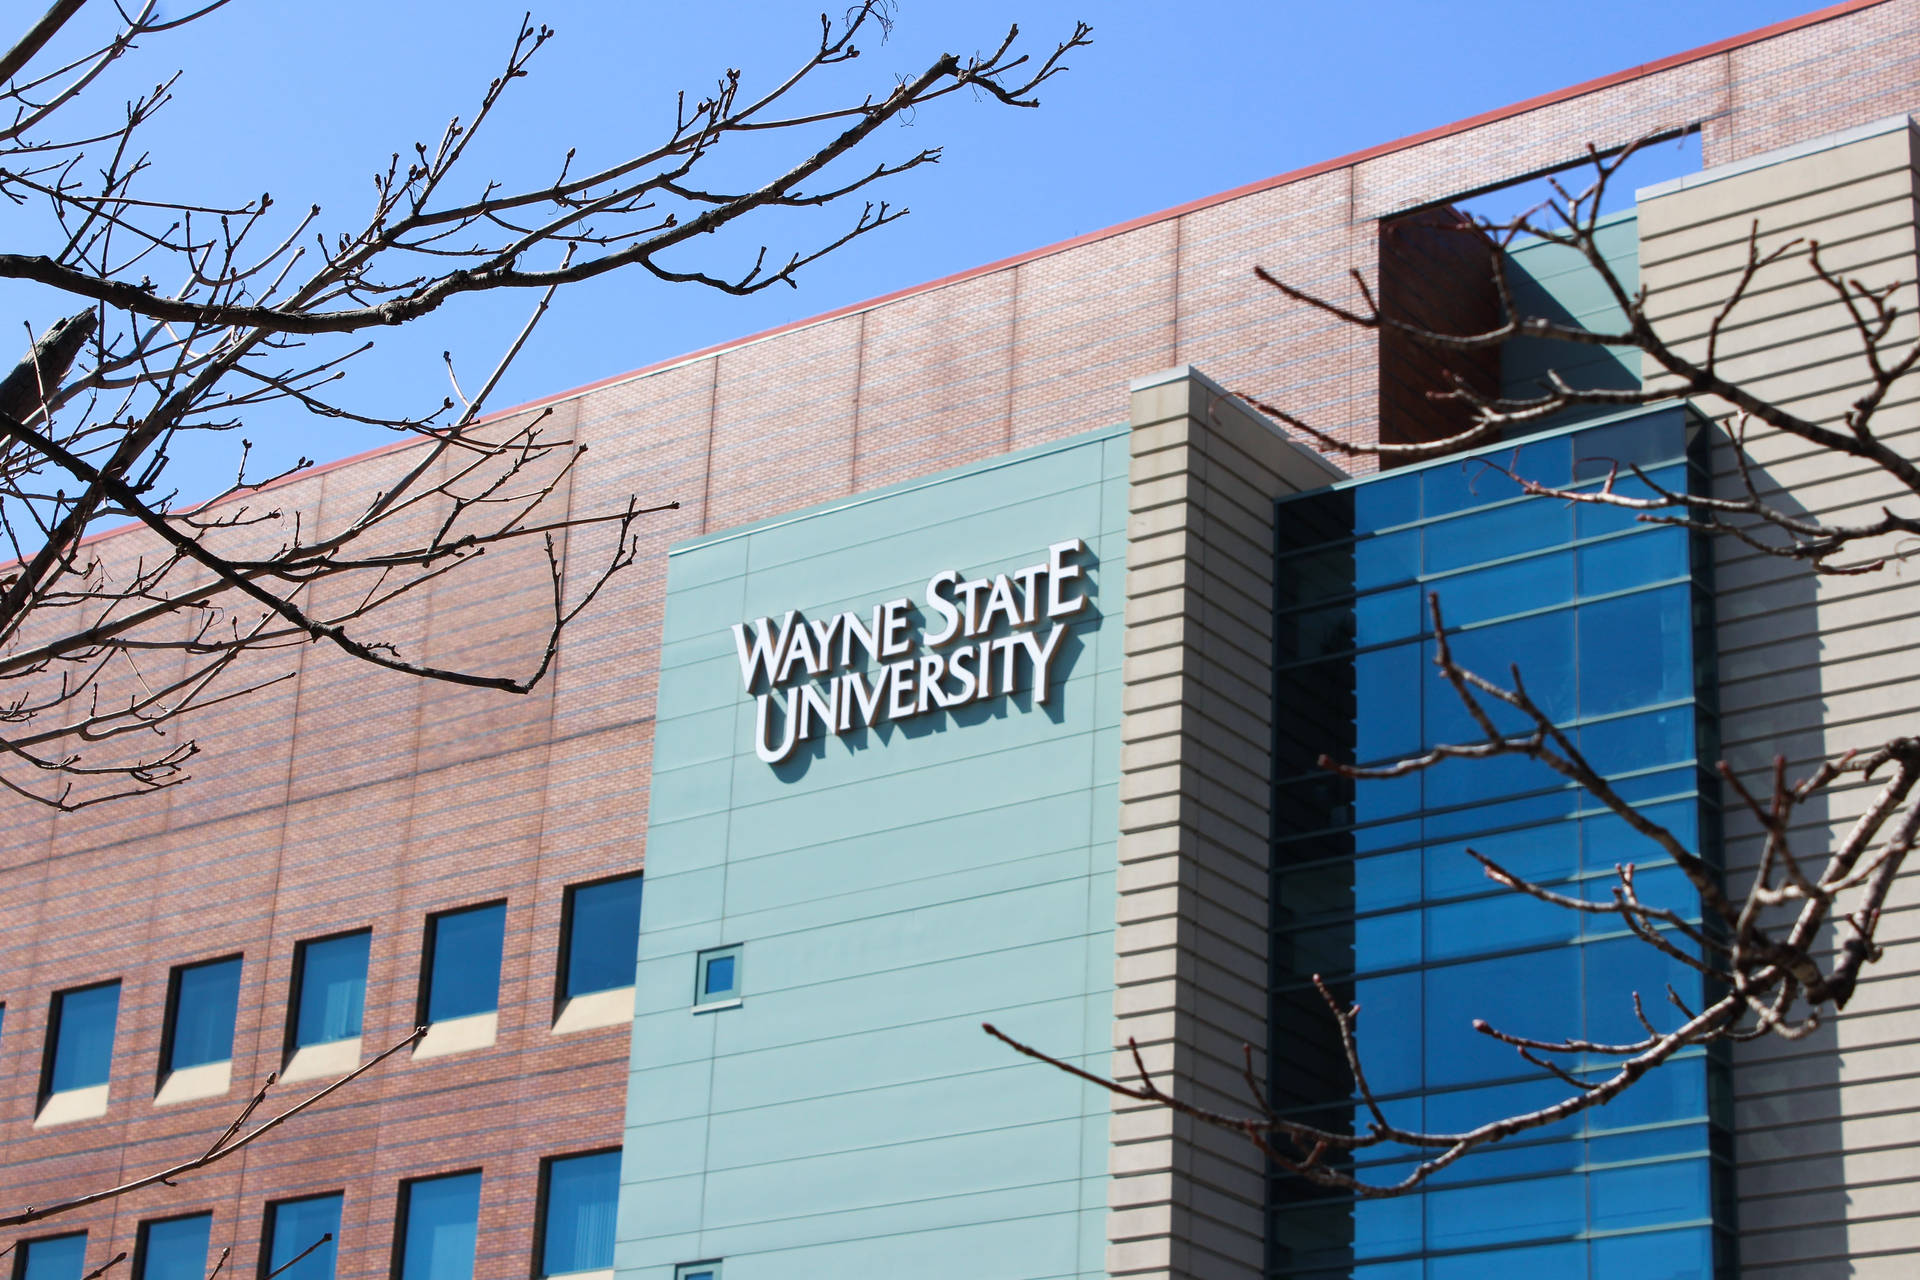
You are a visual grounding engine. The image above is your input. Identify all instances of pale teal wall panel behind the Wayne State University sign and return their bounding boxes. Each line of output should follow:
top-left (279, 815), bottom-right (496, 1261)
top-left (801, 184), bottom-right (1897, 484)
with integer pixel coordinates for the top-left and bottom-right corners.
top-left (614, 428), bottom-right (1129, 1280)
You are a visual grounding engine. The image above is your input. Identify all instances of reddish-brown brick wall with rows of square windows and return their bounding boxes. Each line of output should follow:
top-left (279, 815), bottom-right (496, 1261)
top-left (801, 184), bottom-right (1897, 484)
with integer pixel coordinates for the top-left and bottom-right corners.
top-left (0, 0), bottom-right (1920, 1280)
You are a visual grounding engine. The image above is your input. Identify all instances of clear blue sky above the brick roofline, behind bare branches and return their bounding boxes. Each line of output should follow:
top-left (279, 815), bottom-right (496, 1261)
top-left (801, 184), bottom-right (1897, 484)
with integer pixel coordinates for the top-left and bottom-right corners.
top-left (22, 0), bottom-right (1835, 495)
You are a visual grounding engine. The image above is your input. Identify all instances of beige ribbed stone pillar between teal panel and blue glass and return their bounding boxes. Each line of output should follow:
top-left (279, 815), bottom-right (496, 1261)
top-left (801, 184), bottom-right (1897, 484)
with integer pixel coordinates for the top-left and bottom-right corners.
top-left (1108, 368), bottom-right (1342, 1280)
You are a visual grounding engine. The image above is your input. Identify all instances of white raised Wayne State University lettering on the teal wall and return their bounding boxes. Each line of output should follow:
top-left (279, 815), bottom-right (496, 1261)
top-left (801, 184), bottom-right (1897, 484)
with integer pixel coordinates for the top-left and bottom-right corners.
top-left (733, 537), bottom-right (1087, 764)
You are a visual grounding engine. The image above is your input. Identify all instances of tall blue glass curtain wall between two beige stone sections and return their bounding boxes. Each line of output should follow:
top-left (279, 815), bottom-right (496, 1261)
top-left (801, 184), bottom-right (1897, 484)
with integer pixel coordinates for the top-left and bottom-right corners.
top-left (1269, 407), bottom-right (1732, 1280)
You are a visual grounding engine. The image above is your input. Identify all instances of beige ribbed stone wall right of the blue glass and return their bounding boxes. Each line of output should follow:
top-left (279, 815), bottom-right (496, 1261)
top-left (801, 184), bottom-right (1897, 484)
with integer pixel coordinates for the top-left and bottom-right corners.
top-left (1640, 117), bottom-right (1920, 1280)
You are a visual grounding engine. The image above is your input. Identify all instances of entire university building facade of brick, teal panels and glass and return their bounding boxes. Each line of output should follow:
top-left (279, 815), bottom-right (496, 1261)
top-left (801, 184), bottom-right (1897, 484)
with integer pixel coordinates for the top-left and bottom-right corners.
top-left (0, 0), bottom-right (1920, 1280)
